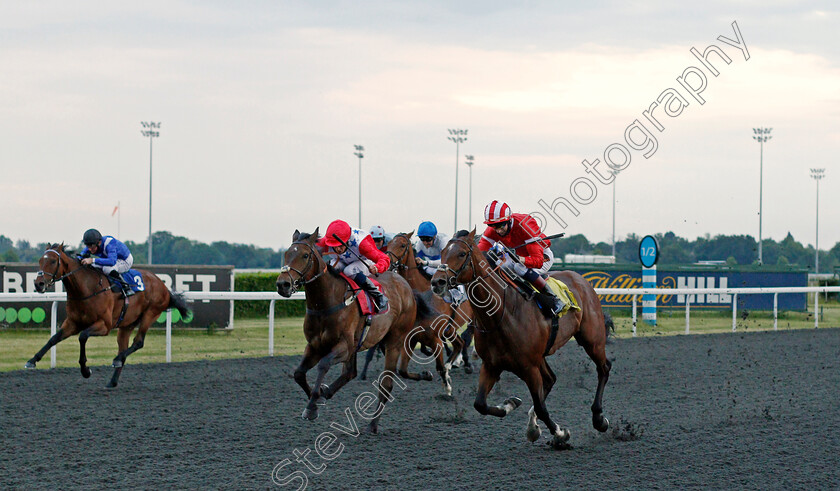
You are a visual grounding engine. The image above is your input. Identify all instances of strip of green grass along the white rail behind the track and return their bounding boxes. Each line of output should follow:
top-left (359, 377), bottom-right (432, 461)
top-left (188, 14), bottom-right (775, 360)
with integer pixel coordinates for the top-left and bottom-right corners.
top-left (0, 301), bottom-right (840, 371)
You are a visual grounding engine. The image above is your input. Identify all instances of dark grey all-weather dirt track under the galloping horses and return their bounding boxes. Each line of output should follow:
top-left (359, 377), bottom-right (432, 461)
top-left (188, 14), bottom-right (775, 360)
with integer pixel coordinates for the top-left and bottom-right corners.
top-left (0, 329), bottom-right (840, 490)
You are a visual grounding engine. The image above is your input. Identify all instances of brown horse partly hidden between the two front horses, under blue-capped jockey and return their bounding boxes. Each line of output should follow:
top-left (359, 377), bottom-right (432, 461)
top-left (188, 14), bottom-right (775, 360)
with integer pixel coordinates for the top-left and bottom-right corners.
top-left (388, 232), bottom-right (472, 395)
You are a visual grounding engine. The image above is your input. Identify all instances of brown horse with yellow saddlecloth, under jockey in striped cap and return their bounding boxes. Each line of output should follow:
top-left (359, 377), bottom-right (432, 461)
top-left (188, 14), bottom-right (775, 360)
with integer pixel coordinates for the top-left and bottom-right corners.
top-left (432, 230), bottom-right (612, 448)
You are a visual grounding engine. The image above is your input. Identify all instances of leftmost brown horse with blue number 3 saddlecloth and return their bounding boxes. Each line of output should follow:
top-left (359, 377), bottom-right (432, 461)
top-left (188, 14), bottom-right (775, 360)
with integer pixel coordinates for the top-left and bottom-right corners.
top-left (24, 244), bottom-right (189, 387)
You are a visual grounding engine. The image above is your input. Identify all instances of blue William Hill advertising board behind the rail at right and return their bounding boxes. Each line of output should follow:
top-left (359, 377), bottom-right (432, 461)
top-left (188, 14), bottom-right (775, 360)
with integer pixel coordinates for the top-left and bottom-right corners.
top-left (552, 264), bottom-right (808, 310)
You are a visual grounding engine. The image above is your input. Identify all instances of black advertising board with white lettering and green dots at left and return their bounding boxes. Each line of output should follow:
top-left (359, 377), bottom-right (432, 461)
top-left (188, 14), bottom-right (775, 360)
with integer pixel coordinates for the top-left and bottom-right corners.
top-left (0, 263), bottom-right (233, 328)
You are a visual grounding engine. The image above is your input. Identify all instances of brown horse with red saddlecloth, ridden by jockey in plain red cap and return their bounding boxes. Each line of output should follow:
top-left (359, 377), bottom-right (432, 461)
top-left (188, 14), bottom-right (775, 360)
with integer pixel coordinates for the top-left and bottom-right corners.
top-left (277, 229), bottom-right (433, 433)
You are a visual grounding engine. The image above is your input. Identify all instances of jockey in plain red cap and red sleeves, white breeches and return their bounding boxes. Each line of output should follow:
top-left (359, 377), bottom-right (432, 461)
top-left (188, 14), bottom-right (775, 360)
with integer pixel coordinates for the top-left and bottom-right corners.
top-left (318, 220), bottom-right (391, 312)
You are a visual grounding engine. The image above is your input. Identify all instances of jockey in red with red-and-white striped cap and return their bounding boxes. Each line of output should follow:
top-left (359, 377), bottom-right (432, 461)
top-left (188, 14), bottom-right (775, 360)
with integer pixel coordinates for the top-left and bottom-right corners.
top-left (478, 200), bottom-right (564, 315)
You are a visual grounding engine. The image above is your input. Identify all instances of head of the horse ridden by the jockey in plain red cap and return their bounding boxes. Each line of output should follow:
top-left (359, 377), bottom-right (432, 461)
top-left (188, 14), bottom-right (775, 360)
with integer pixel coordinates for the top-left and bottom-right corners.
top-left (276, 228), bottom-right (326, 298)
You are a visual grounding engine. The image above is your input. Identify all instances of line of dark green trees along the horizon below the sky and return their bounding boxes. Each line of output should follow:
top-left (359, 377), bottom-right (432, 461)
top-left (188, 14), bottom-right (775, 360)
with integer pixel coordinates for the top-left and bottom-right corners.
top-left (0, 232), bottom-right (840, 273)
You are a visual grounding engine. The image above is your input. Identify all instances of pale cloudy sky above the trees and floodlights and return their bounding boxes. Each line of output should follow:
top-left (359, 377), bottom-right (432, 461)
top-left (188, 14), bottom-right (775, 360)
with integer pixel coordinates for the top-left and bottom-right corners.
top-left (0, 0), bottom-right (840, 259)
